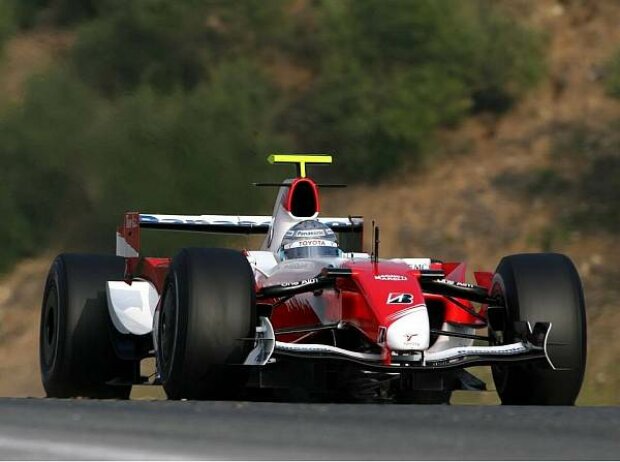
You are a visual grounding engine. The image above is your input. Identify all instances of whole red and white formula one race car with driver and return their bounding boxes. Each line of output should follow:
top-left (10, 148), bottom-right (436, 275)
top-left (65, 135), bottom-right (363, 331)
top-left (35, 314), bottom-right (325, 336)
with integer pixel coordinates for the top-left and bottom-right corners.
top-left (40, 154), bottom-right (586, 405)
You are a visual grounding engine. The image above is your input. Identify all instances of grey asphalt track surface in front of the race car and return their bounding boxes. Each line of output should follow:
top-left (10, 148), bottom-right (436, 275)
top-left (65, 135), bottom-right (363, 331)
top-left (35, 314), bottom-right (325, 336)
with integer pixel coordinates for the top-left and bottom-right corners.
top-left (0, 399), bottom-right (620, 460)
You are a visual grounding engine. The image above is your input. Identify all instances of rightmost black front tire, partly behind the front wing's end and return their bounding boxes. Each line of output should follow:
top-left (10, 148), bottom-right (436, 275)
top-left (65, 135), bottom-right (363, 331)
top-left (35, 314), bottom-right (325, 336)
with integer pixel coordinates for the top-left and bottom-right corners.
top-left (490, 253), bottom-right (586, 405)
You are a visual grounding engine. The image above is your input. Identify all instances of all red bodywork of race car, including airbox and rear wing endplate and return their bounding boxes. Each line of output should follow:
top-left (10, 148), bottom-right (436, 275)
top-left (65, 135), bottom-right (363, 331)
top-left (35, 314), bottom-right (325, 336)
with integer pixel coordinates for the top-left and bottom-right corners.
top-left (118, 178), bottom-right (492, 363)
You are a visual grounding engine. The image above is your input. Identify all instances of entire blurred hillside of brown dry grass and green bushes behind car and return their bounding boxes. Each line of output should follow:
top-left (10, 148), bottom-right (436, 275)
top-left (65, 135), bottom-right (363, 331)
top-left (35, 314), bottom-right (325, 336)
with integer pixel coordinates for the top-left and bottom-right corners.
top-left (0, 0), bottom-right (620, 405)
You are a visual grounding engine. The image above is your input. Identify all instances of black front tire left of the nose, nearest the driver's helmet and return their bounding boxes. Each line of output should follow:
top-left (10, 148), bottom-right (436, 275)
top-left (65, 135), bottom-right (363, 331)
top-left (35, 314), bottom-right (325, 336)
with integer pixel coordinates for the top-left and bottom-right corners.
top-left (157, 248), bottom-right (257, 399)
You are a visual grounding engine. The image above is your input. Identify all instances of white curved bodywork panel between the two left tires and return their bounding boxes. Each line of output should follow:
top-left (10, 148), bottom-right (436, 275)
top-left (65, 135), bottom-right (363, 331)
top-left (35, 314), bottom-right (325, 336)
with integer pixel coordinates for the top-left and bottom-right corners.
top-left (106, 280), bottom-right (159, 335)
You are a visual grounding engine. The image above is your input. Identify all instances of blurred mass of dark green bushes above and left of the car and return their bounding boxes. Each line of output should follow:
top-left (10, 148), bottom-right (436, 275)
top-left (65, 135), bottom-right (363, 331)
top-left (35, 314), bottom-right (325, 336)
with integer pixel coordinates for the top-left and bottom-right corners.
top-left (0, 0), bottom-right (548, 268)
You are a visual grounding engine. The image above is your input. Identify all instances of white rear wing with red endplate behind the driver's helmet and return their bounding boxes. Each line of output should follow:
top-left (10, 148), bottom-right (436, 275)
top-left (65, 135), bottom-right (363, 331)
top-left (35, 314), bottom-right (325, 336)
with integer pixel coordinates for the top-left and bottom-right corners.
top-left (116, 212), bottom-right (364, 258)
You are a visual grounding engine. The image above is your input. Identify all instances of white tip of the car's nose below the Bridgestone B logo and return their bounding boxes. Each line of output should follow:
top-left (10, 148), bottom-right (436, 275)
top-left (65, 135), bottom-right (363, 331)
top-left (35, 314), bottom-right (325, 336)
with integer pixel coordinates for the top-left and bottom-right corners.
top-left (386, 305), bottom-right (430, 351)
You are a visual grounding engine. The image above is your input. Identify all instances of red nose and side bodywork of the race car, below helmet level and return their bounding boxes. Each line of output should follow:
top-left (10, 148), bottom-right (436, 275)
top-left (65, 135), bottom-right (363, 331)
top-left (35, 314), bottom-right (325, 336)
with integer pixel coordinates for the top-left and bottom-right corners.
top-left (133, 249), bottom-right (491, 363)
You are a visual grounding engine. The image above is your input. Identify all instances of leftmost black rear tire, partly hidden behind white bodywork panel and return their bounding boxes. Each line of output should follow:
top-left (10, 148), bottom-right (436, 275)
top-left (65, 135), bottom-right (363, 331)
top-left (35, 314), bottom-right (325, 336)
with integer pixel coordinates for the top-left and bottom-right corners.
top-left (39, 254), bottom-right (135, 399)
